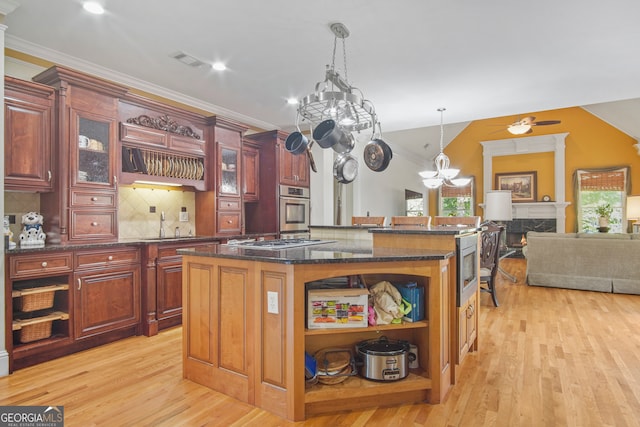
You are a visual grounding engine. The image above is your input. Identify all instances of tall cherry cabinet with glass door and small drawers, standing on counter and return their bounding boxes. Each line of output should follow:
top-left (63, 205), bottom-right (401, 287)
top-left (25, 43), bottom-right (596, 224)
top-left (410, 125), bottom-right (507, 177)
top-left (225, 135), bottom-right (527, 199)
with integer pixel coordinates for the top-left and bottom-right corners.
top-left (33, 66), bottom-right (127, 243)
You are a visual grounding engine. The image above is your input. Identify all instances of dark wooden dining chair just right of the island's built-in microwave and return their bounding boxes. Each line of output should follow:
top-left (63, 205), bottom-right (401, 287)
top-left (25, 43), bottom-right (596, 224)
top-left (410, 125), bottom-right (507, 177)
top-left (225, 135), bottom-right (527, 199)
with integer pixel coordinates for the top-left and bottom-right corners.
top-left (479, 221), bottom-right (504, 307)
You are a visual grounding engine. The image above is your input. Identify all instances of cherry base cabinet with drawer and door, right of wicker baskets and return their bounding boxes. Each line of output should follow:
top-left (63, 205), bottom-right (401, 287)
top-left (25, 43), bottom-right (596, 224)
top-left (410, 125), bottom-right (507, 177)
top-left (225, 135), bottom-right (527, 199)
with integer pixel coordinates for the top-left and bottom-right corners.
top-left (73, 248), bottom-right (140, 340)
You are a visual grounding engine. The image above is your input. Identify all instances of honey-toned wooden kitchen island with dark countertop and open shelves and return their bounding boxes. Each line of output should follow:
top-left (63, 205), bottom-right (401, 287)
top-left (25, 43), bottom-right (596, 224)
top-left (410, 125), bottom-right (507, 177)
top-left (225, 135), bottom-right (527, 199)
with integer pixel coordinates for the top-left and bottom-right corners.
top-left (179, 240), bottom-right (453, 421)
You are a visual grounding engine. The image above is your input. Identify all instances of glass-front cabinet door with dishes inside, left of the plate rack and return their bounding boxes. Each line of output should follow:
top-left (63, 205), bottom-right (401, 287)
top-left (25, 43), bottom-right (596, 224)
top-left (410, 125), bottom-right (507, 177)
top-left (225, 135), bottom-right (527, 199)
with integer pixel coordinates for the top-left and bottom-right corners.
top-left (70, 111), bottom-right (116, 187)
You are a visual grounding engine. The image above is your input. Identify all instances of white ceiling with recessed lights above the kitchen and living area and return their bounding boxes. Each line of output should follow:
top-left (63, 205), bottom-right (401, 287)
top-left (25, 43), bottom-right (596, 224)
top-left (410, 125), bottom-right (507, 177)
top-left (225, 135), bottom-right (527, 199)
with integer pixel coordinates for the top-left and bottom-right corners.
top-left (5, 0), bottom-right (640, 162)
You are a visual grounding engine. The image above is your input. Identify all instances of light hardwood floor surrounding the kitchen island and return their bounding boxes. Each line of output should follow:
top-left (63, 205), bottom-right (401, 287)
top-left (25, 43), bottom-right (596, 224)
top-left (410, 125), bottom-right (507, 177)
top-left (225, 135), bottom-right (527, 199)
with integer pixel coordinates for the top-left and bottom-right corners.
top-left (0, 259), bottom-right (640, 427)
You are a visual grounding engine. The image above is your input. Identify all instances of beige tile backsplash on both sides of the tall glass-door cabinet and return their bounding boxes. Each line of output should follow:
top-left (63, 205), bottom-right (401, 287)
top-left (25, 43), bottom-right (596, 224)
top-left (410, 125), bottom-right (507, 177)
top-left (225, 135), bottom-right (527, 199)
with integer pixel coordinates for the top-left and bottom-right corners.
top-left (4, 187), bottom-right (196, 241)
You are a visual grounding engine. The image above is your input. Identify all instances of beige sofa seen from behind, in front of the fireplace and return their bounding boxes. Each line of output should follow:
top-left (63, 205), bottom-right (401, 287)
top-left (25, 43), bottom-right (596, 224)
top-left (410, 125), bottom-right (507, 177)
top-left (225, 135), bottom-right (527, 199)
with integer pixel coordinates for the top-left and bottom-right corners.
top-left (525, 231), bottom-right (640, 294)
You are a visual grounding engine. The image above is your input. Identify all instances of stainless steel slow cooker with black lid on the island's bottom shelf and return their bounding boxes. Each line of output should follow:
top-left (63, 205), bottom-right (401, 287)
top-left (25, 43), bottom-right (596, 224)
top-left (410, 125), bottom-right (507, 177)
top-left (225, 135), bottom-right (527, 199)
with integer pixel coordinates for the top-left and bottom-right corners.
top-left (356, 337), bottom-right (409, 381)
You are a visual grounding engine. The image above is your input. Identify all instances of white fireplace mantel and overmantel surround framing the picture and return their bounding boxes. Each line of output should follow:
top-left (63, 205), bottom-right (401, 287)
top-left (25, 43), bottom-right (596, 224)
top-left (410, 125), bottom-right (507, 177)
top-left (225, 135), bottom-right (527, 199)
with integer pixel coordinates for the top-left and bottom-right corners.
top-left (480, 133), bottom-right (569, 233)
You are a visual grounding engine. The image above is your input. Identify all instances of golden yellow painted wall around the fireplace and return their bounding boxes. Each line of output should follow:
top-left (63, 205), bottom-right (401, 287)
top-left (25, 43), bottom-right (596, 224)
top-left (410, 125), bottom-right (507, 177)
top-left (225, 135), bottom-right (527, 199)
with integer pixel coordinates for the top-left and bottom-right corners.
top-left (430, 107), bottom-right (640, 232)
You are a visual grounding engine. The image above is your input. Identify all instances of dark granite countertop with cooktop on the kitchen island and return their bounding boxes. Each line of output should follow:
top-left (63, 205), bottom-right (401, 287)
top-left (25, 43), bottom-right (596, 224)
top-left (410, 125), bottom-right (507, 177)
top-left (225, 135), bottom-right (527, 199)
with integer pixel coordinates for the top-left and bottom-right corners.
top-left (178, 240), bottom-right (454, 264)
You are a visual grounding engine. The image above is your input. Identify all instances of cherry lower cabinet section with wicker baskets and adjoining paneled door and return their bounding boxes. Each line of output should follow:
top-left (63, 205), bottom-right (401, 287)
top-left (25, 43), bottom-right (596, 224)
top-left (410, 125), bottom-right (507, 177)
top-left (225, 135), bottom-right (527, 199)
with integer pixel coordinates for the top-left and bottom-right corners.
top-left (5, 247), bottom-right (141, 371)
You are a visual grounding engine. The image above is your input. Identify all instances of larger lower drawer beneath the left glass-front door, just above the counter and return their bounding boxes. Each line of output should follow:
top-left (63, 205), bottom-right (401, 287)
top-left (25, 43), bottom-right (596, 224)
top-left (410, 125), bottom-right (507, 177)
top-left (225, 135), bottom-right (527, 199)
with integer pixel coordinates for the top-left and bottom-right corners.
top-left (69, 209), bottom-right (118, 240)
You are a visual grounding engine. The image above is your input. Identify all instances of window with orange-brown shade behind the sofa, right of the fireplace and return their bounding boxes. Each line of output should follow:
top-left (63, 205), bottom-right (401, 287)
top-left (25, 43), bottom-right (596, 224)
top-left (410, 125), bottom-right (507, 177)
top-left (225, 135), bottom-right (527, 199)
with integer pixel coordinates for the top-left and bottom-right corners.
top-left (573, 166), bottom-right (630, 233)
